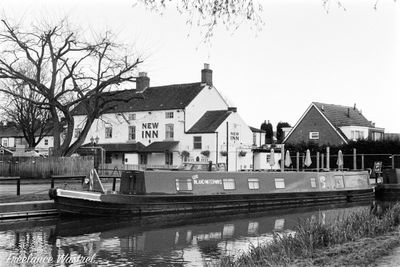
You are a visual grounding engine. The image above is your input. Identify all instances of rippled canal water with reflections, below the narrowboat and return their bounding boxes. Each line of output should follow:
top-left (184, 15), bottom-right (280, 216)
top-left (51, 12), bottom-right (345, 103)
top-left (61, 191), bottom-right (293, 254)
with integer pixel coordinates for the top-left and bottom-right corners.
top-left (0, 203), bottom-right (372, 266)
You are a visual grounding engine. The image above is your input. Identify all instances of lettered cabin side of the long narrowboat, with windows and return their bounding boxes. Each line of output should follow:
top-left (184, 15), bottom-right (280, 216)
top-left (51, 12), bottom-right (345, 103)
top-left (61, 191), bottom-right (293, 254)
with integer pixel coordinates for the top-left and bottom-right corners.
top-left (144, 171), bottom-right (370, 195)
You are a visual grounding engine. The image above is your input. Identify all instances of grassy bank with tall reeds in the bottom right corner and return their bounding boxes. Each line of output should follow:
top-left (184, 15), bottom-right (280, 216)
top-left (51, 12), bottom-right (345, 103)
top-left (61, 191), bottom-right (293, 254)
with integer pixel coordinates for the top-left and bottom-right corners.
top-left (221, 203), bottom-right (400, 266)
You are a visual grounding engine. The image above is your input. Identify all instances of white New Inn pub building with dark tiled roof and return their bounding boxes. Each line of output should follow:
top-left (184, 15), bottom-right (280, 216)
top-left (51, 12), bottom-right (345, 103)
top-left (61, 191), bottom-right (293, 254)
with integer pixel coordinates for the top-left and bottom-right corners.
top-left (73, 64), bottom-right (272, 171)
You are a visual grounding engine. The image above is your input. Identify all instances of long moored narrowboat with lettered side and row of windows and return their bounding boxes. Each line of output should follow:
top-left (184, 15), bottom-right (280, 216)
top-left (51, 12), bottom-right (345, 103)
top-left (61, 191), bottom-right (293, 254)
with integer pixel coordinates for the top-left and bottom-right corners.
top-left (49, 170), bottom-right (374, 216)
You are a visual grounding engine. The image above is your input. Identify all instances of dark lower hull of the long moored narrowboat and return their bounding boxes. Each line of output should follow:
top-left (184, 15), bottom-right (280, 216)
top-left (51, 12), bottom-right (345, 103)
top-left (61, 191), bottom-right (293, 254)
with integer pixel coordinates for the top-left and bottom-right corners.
top-left (50, 189), bottom-right (374, 216)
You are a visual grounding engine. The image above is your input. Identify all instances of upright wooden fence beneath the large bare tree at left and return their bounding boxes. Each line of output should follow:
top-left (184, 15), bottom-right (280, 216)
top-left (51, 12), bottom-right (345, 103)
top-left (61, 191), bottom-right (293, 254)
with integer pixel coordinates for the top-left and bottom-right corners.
top-left (0, 156), bottom-right (94, 178)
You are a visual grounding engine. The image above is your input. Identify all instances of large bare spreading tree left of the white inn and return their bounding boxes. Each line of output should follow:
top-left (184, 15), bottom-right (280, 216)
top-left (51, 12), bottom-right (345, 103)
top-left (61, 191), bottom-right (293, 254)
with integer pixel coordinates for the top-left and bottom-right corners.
top-left (0, 20), bottom-right (142, 156)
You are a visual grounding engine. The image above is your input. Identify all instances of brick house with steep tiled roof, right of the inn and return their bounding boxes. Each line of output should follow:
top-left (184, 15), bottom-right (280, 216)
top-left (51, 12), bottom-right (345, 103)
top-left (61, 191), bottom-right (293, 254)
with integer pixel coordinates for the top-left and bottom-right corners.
top-left (283, 102), bottom-right (384, 145)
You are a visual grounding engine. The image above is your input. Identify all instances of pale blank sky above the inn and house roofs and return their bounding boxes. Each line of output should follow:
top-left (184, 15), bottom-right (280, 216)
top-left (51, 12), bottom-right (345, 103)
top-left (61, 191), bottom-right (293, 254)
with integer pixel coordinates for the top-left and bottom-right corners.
top-left (0, 0), bottom-right (400, 133)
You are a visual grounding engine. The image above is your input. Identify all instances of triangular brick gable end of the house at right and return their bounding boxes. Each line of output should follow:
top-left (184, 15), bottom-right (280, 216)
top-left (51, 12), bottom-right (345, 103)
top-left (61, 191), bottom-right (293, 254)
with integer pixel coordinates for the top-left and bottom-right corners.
top-left (284, 104), bottom-right (346, 145)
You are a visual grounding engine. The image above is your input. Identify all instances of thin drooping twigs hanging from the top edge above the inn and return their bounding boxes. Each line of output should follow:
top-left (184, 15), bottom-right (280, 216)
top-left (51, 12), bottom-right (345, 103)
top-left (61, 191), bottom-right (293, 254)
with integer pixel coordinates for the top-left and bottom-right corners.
top-left (136, 0), bottom-right (263, 41)
